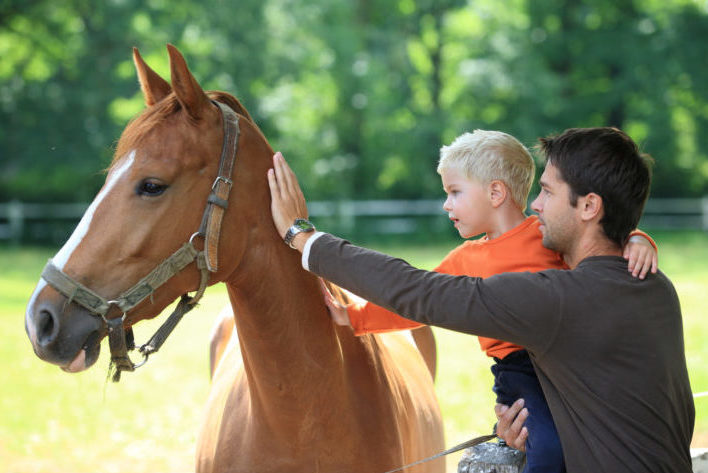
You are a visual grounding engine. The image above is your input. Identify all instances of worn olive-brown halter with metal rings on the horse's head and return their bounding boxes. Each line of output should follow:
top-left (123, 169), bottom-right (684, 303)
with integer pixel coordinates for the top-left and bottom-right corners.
top-left (42, 101), bottom-right (240, 382)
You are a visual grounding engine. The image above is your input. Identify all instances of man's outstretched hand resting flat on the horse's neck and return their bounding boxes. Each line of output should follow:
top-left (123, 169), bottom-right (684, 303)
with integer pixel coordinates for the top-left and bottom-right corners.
top-left (268, 151), bottom-right (312, 252)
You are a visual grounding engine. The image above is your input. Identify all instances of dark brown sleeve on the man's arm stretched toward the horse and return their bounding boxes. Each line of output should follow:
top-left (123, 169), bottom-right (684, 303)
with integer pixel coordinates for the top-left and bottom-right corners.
top-left (308, 234), bottom-right (562, 355)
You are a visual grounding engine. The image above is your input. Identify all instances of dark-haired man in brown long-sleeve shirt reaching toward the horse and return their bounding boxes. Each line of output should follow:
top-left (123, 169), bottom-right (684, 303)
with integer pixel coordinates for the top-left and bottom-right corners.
top-left (268, 128), bottom-right (694, 473)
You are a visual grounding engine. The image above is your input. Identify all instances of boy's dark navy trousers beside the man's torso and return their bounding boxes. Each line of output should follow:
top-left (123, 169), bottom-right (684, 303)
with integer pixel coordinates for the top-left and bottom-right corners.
top-left (492, 350), bottom-right (565, 473)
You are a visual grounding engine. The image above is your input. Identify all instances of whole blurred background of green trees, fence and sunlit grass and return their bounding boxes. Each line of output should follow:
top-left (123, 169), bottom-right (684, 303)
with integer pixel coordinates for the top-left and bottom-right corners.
top-left (0, 0), bottom-right (708, 473)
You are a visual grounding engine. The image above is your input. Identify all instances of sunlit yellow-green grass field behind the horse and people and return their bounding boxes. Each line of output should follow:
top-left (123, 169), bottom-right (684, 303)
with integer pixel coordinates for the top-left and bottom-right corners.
top-left (0, 232), bottom-right (708, 473)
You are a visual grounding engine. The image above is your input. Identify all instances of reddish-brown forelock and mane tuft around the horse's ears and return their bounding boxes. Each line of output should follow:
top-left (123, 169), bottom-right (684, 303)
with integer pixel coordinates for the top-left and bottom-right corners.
top-left (108, 91), bottom-right (265, 169)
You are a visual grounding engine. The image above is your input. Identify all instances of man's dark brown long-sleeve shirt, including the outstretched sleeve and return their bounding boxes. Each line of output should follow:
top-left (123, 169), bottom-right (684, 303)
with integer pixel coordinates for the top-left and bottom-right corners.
top-left (307, 234), bottom-right (695, 473)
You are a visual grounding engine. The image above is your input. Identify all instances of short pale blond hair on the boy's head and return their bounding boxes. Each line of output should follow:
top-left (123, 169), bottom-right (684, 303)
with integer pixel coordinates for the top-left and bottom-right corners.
top-left (438, 130), bottom-right (535, 211)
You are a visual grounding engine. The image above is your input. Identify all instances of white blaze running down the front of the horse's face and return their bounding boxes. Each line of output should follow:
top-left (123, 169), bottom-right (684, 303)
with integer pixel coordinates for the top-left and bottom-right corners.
top-left (25, 150), bottom-right (135, 344)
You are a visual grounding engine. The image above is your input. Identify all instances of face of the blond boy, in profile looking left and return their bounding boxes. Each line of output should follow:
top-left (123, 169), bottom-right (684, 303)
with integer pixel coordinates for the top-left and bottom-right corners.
top-left (440, 168), bottom-right (491, 238)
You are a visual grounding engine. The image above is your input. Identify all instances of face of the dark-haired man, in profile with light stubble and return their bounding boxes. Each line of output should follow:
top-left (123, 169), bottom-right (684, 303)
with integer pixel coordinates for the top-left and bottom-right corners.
top-left (531, 163), bottom-right (579, 254)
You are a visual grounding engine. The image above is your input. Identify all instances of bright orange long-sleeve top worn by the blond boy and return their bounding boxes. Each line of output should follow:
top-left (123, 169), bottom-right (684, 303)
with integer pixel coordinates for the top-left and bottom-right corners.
top-left (347, 216), bottom-right (568, 358)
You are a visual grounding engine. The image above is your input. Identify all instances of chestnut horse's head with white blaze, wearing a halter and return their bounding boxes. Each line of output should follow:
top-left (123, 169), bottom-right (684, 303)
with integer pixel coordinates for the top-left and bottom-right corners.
top-left (25, 45), bottom-right (278, 372)
